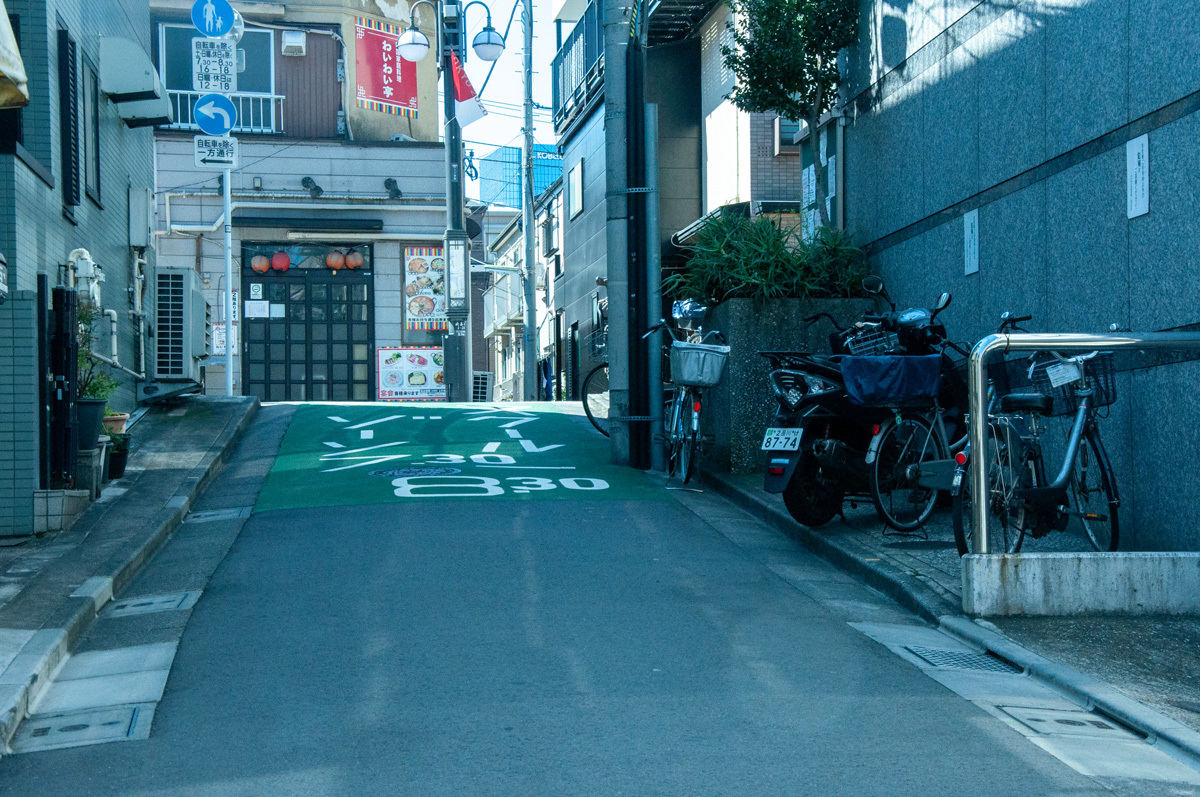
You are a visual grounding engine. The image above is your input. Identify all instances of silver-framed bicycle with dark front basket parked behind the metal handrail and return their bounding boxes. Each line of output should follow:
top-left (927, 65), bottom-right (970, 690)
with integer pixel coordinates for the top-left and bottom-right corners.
top-left (952, 352), bottom-right (1121, 555)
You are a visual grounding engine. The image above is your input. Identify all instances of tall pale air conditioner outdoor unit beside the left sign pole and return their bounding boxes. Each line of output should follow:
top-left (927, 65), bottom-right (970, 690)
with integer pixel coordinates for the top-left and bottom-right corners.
top-left (140, 268), bottom-right (212, 401)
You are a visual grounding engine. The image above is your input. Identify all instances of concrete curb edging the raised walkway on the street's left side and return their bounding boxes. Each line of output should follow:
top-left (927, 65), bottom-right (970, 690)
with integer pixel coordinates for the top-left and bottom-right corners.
top-left (0, 399), bottom-right (258, 754)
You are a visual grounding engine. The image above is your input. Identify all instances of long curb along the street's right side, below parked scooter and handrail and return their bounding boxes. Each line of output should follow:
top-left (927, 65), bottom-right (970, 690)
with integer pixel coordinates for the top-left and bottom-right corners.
top-left (702, 472), bottom-right (1200, 768)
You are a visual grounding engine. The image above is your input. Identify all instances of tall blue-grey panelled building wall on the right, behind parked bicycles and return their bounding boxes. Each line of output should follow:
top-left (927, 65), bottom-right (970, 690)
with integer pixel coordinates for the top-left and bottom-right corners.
top-left (845, 0), bottom-right (1200, 550)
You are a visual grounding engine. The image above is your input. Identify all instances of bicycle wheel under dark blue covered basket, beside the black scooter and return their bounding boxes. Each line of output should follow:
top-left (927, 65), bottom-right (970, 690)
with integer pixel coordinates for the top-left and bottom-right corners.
top-left (869, 415), bottom-right (946, 532)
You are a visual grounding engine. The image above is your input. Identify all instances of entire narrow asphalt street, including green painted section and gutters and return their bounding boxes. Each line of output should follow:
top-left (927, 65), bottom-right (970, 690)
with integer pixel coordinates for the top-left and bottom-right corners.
top-left (0, 405), bottom-right (1196, 796)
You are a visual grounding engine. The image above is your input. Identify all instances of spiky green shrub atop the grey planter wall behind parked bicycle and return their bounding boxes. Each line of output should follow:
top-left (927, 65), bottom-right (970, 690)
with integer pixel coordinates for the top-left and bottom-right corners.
top-left (662, 212), bottom-right (868, 305)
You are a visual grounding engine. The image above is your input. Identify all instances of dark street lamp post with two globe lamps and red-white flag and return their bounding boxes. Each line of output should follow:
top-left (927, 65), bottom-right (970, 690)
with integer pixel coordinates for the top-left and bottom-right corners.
top-left (396, 0), bottom-right (504, 402)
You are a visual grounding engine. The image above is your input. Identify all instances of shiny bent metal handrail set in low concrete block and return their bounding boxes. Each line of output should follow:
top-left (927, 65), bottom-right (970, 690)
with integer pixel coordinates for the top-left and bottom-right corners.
top-left (967, 332), bottom-right (1200, 553)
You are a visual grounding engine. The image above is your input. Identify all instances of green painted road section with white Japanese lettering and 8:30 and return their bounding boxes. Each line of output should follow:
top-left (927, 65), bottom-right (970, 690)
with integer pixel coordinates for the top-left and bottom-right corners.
top-left (254, 403), bottom-right (666, 511)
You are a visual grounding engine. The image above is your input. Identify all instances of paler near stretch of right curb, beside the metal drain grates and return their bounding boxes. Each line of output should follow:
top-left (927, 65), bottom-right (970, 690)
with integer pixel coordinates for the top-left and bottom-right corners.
top-left (938, 615), bottom-right (1200, 769)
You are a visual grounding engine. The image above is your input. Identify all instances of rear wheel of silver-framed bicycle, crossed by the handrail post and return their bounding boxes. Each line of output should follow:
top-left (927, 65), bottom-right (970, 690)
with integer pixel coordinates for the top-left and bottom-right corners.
top-left (954, 419), bottom-right (1033, 556)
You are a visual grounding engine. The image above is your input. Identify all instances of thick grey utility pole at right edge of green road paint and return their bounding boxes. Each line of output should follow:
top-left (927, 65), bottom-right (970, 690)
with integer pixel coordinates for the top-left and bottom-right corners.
top-left (600, 0), bottom-right (630, 465)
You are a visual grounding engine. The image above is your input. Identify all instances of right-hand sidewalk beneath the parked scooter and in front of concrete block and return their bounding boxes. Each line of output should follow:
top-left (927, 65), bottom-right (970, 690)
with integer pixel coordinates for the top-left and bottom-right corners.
top-left (704, 473), bottom-right (1200, 759)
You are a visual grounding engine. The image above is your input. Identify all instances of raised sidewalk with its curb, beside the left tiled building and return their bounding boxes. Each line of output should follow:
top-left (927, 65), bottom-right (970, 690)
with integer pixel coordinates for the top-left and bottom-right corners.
top-left (0, 396), bottom-right (258, 749)
